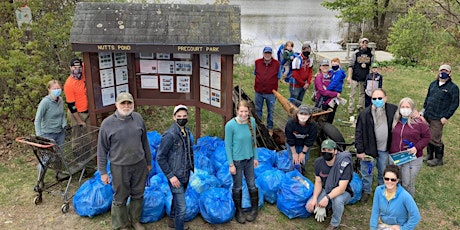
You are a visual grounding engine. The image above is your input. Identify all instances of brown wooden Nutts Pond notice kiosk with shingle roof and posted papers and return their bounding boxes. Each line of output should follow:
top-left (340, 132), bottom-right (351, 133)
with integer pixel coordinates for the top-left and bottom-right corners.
top-left (70, 2), bottom-right (241, 137)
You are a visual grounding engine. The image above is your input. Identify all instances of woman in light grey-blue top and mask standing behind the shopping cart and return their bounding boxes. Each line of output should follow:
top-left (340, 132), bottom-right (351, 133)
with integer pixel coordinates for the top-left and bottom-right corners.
top-left (34, 80), bottom-right (67, 189)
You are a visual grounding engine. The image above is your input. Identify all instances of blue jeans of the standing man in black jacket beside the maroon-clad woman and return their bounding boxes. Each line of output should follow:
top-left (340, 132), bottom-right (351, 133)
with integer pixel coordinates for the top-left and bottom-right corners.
top-left (361, 151), bottom-right (390, 194)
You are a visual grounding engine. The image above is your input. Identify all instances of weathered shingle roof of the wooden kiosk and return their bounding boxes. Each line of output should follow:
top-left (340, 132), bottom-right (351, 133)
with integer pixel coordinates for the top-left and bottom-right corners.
top-left (70, 2), bottom-right (241, 52)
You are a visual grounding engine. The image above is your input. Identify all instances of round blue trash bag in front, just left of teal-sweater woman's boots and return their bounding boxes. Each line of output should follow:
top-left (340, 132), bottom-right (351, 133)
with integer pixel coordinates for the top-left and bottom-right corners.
top-left (200, 188), bottom-right (235, 224)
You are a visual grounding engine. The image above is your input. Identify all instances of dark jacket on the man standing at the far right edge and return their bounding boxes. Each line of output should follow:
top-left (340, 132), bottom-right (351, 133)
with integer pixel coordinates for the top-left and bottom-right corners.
top-left (423, 79), bottom-right (459, 120)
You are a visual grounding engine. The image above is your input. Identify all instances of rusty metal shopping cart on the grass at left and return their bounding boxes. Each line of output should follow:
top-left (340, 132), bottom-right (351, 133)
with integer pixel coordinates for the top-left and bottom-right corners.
top-left (16, 126), bottom-right (99, 213)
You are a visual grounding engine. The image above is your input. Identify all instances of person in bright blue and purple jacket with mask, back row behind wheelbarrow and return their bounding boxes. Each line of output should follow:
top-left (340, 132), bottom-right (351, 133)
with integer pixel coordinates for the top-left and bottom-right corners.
top-left (326, 58), bottom-right (347, 108)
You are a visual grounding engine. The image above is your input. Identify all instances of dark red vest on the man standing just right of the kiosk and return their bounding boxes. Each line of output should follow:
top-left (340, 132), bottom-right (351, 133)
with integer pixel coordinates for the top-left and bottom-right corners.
top-left (254, 58), bottom-right (280, 94)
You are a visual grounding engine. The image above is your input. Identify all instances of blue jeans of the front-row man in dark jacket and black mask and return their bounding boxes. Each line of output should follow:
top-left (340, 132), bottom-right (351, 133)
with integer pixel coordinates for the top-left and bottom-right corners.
top-left (168, 183), bottom-right (187, 230)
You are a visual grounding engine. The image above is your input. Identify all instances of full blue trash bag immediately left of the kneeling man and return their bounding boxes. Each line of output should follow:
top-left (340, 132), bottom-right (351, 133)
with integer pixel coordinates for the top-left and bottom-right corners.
top-left (276, 170), bottom-right (314, 219)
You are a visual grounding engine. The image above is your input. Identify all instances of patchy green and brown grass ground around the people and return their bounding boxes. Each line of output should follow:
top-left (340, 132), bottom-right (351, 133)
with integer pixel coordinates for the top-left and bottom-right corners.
top-left (0, 63), bottom-right (460, 229)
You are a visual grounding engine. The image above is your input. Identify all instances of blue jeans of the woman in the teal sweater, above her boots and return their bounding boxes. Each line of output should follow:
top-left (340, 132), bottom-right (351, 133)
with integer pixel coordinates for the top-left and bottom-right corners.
top-left (232, 157), bottom-right (256, 193)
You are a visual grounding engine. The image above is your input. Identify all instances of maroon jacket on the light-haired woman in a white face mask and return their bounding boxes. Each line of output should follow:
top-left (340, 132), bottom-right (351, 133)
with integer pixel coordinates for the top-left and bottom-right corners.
top-left (390, 118), bottom-right (431, 157)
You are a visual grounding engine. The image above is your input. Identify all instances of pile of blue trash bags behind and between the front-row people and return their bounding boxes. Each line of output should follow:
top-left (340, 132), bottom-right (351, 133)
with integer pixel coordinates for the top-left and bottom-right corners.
top-left (73, 131), bottom-right (362, 224)
